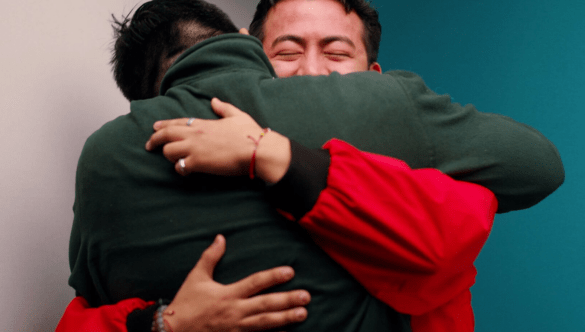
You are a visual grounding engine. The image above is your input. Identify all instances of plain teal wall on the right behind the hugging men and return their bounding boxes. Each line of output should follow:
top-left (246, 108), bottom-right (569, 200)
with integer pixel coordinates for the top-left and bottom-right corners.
top-left (373, 0), bottom-right (585, 332)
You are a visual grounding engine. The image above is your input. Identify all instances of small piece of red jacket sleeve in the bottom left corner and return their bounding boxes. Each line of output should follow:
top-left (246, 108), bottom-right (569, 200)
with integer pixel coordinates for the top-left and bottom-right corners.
top-left (56, 296), bottom-right (154, 332)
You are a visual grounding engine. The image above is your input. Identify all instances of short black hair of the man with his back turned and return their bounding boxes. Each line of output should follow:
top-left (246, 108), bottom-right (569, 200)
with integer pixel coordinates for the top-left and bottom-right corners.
top-left (111, 0), bottom-right (238, 101)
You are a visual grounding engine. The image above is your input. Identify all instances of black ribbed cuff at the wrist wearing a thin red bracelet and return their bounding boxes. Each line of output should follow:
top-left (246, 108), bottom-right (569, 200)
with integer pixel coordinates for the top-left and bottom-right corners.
top-left (267, 140), bottom-right (331, 220)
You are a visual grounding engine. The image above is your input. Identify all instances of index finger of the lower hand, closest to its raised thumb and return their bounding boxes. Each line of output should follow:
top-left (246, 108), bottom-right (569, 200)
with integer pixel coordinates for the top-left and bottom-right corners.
top-left (229, 266), bottom-right (294, 298)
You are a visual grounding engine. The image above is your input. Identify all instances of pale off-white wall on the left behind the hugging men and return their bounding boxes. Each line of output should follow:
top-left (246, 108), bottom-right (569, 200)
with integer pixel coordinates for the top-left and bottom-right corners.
top-left (0, 0), bottom-right (256, 331)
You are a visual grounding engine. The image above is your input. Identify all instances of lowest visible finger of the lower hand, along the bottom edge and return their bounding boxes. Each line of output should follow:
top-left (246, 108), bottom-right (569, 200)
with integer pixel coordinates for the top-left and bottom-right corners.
top-left (240, 308), bottom-right (307, 331)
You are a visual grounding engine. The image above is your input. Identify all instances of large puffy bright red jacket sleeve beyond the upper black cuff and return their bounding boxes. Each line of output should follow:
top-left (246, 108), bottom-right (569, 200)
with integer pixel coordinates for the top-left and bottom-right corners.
top-left (299, 140), bottom-right (497, 315)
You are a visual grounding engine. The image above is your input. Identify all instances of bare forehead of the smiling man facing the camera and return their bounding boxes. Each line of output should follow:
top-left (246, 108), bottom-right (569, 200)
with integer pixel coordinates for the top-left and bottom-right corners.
top-left (264, 0), bottom-right (364, 46)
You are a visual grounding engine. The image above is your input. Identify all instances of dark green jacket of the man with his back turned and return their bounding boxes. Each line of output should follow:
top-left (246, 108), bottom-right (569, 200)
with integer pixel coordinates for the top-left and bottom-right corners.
top-left (69, 34), bottom-right (564, 332)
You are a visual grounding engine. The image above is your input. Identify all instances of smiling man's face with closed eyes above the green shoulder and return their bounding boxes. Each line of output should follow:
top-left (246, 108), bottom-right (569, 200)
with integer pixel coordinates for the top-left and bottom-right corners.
top-left (262, 0), bottom-right (381, 77)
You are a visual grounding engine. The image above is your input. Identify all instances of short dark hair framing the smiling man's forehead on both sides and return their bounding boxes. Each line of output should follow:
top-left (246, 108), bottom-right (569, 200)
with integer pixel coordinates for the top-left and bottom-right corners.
top-left (249, 0), bottom-right (382, 65)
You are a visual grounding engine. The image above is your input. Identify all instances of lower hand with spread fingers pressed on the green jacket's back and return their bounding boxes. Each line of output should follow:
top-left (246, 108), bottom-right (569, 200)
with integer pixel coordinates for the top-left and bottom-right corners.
top-left (163, 235), bottom-right (310, 332)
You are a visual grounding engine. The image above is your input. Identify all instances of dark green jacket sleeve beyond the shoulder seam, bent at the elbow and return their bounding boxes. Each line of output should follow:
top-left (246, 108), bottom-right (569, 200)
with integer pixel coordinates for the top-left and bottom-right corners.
top-left (396, 72), bottom-right (564, 213)
